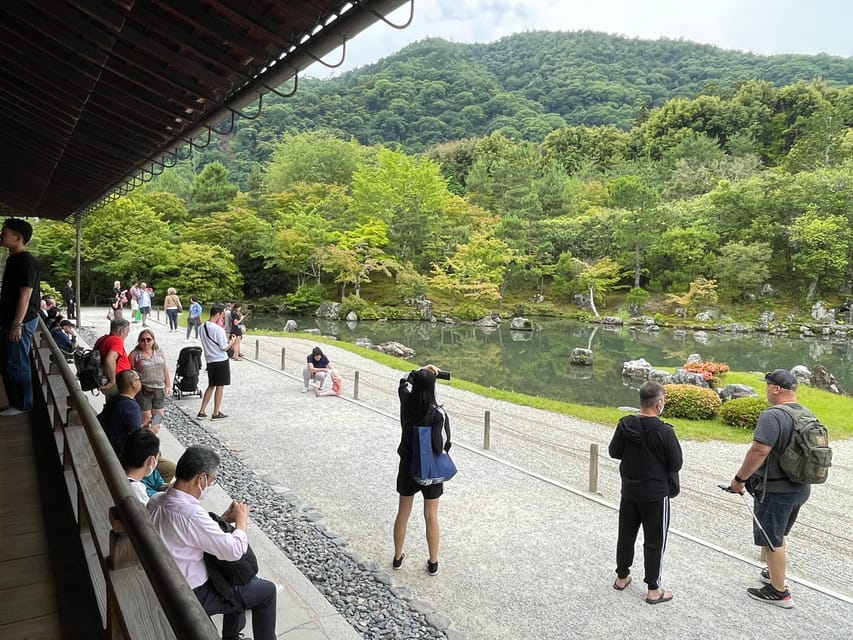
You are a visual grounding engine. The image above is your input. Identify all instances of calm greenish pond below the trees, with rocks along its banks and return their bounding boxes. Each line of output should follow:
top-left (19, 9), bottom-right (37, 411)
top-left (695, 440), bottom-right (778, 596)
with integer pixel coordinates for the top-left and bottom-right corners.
top-left (243, 315), bottom-right (853, 406)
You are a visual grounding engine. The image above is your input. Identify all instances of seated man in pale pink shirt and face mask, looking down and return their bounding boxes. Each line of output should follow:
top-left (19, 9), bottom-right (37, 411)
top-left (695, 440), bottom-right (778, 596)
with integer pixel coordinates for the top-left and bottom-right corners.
top-left (146, 445), bottom-right (276, 640)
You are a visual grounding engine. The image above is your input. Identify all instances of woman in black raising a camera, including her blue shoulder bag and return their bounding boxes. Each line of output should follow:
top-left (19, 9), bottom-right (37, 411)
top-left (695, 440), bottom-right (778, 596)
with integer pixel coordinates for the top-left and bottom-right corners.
top-left (392, 364), bottom-right (456, 576)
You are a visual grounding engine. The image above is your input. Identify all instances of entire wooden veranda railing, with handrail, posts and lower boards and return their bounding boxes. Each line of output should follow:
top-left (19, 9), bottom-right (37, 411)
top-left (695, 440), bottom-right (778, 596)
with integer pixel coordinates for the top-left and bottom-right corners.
top-left (34, 320), bottom-right (219, 640)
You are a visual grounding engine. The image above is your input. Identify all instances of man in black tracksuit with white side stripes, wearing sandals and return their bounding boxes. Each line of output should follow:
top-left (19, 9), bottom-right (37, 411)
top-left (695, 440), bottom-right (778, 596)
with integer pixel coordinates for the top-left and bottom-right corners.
top-left (610, 382), bottom-right (682, 604)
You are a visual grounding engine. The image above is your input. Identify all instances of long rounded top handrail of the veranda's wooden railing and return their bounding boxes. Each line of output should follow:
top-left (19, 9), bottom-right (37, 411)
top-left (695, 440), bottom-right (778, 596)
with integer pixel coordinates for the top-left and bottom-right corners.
top-left (35, 318), bottom-right (219, 640)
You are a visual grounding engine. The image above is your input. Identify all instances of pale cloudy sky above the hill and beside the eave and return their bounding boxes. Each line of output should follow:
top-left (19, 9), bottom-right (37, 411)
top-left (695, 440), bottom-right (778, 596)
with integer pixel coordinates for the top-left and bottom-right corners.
top-left (308, 0), bottom-right (853, 77)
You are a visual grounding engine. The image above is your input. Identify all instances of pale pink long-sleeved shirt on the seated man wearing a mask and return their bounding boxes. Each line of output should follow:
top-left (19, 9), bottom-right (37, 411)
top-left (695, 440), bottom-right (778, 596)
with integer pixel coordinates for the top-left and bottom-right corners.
top-left (146, 487), bottom-right (249, 589)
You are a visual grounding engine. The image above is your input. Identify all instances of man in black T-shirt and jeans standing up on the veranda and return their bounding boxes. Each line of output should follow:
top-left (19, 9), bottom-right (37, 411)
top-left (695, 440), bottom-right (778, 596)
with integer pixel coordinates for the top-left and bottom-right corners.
top-left (0, 218), bottom-right (41, 416)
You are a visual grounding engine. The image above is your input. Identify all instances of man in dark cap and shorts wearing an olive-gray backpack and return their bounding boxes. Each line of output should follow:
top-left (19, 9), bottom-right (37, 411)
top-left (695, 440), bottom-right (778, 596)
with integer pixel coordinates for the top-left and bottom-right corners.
top-left (728, 369), bottom-right (832, 609)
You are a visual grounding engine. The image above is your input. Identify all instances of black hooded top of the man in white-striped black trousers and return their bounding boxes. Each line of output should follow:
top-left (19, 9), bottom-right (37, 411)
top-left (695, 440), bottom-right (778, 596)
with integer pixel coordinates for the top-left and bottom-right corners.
top-left (610, 415), bottom-right (682, 500)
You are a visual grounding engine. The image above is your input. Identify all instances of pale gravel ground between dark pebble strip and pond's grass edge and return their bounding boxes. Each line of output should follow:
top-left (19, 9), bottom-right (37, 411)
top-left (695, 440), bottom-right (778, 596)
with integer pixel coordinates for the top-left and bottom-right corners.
top-left (76, 314), bottom-right (853, 639)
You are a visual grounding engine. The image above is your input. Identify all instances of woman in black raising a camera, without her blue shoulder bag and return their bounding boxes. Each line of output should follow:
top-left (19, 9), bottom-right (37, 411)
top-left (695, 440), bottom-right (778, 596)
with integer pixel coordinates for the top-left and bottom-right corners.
top-left (392, 364), bottom-right (451, 576)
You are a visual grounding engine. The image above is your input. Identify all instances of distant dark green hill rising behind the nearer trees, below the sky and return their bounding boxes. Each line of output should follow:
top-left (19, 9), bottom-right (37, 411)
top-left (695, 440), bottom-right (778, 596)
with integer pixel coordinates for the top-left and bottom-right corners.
top-left (211, 31), bottom-right (853, 166)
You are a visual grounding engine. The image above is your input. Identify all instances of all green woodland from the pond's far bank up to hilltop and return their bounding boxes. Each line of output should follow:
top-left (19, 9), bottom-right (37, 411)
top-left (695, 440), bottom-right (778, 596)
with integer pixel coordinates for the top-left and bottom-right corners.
top-left (33, 33), bottom-right (853, 317)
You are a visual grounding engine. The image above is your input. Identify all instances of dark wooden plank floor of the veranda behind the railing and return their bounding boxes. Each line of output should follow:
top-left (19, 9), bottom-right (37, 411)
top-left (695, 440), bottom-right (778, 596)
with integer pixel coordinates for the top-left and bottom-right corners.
top-left (0, 382), bottom-right (103, 640)
